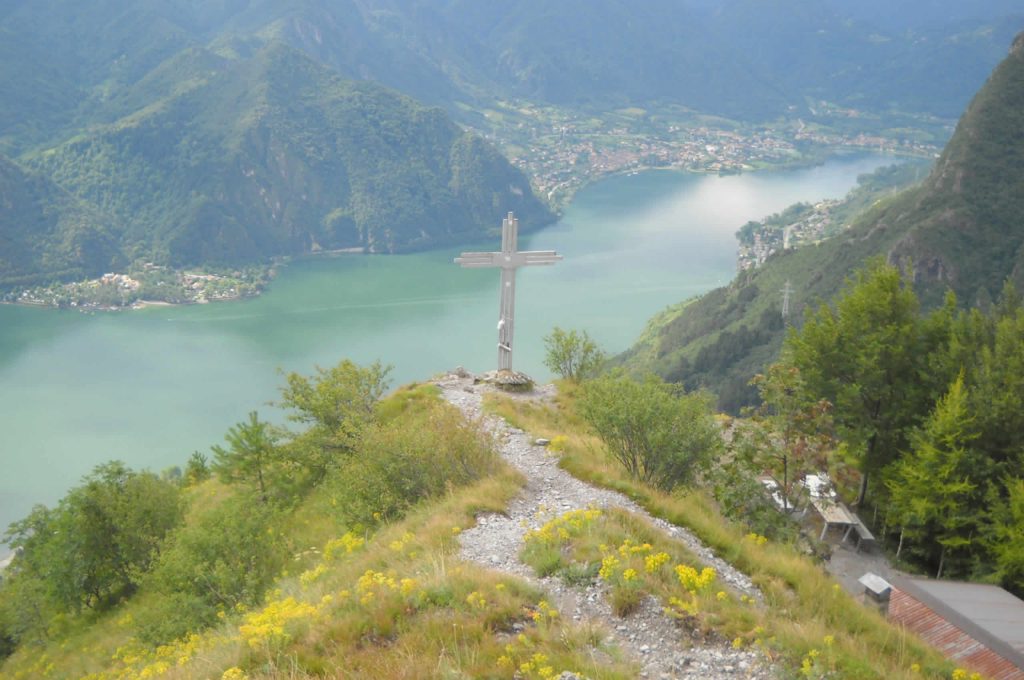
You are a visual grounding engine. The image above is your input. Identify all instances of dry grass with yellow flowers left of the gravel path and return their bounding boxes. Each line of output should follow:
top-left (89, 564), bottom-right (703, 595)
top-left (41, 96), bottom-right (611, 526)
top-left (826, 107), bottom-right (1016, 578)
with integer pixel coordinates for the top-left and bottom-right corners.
top-left (0, 387), bottom-right (635, 680)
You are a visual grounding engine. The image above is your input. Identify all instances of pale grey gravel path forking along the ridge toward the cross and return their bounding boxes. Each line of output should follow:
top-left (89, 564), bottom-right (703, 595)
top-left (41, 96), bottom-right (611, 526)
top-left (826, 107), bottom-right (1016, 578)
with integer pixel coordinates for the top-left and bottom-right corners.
top-left (436, 372), bottom-right (773, 680)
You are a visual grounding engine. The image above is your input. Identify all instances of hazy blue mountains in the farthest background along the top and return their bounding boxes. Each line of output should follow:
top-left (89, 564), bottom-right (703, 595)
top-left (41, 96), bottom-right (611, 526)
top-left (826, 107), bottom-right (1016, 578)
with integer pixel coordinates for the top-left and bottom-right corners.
top-left (0, 0), bottom-right (1024, 147)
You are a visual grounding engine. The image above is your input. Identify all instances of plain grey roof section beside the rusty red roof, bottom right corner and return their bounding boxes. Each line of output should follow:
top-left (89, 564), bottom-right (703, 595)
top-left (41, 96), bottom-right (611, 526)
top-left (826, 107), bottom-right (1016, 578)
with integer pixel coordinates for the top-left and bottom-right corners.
top-left (892, 578), bottom-right (1024, 669)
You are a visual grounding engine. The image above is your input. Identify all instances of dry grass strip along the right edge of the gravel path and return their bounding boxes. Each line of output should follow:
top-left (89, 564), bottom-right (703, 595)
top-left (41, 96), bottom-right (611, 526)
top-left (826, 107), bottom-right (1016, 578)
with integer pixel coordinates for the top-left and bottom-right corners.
top-left (485, 384), bottom-right (966, 679)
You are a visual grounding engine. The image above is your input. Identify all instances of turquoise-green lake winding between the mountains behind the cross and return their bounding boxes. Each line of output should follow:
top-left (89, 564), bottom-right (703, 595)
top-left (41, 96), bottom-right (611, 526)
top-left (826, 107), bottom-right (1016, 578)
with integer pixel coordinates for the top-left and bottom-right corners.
top-left (0, 156), bottom-right (893, 558)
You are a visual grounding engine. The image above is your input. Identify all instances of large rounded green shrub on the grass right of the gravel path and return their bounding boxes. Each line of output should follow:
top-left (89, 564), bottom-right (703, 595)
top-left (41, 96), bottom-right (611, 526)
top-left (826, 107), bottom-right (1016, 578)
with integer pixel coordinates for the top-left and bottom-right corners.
top-left (580, 374), bottom-right (722, 490)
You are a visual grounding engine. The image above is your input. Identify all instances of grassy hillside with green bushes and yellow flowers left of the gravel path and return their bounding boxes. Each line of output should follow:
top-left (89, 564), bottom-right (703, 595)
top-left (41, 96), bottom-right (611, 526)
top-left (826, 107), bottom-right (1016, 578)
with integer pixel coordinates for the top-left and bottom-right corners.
top-left (0, 362), bottom-right (631, 680)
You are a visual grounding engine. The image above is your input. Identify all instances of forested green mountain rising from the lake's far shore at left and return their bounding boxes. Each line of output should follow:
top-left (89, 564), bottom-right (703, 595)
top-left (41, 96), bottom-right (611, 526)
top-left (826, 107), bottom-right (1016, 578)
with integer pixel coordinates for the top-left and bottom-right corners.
top-left (0, 43), bottom-right (552, 288)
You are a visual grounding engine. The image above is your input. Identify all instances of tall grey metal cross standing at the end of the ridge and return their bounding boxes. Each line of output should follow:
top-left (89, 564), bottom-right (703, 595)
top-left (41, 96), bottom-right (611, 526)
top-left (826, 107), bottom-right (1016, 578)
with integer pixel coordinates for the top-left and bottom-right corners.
top-left (455, 213), bottom-right (562, 371)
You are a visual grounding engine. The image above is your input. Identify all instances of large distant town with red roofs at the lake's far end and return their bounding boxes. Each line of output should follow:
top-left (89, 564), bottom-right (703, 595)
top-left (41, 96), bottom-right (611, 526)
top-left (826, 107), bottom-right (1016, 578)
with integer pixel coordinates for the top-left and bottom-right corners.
top-left (478, 102), bottom-right (940, 209)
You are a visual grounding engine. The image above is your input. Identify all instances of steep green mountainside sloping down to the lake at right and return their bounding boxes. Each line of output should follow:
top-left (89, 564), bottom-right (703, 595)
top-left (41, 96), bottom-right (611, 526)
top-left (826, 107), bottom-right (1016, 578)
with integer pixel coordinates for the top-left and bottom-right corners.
top-left (622, 34), bottom-right (1024, 412)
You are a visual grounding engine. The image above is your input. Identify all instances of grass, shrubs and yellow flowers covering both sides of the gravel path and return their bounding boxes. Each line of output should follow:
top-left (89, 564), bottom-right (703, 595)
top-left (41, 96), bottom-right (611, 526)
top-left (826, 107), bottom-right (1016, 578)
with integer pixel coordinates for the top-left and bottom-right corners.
top-left (0, 362), bottom-right (966, 680)
